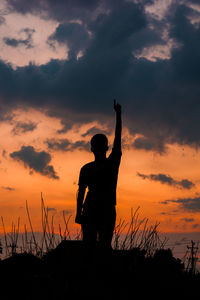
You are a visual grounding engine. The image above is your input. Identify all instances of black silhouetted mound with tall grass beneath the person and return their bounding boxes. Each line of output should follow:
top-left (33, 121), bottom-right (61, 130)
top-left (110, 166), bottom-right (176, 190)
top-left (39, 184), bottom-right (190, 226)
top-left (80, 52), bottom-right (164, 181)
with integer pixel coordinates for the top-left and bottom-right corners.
top-left (0, 197), bottom-right (200, 299)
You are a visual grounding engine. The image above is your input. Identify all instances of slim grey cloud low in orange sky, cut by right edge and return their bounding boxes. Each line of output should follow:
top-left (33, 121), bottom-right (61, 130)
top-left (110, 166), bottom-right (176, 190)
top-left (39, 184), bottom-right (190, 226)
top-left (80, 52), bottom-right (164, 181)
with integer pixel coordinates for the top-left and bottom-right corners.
top-left (161, 197), bottom-right (200, 213)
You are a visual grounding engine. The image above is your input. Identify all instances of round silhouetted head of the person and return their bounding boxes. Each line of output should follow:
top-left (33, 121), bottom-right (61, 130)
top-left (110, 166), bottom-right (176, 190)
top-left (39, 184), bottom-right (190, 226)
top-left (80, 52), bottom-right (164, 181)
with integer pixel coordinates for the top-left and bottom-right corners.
top-left (90, 133), bottom-right (108, 155)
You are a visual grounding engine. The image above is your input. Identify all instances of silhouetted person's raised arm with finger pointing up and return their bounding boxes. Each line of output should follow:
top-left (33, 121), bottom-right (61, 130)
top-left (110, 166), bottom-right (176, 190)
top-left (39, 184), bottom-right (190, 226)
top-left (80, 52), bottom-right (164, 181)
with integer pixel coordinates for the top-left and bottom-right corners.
top-left (113, 100), bottom-right (122, 152)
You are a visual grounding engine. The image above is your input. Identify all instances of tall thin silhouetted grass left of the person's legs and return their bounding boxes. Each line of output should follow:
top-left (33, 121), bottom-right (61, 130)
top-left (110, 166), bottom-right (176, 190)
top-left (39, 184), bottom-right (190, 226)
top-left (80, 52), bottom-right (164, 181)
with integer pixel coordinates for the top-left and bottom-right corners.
top-left (0, 194), bottom-right (81, 258)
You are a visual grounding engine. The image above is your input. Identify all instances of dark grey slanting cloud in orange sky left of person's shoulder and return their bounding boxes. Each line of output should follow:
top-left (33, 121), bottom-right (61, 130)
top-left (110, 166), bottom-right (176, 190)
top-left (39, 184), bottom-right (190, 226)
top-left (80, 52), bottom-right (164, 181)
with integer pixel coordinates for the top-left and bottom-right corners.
top-left (10, 146), bottom-right (59, 179)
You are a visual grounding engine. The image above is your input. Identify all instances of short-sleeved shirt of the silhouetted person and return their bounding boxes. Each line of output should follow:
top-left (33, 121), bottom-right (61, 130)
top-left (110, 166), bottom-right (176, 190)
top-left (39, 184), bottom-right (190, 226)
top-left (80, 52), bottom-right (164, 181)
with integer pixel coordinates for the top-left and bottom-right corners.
top-left (79, 148), bottom-right (122, 207)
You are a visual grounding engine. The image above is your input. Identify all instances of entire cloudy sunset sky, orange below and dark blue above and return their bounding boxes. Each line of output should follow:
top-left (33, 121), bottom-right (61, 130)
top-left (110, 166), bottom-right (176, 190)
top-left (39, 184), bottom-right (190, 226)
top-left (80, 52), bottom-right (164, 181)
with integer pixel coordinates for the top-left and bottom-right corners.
top-left (0, 0), bottom-right (200, 237)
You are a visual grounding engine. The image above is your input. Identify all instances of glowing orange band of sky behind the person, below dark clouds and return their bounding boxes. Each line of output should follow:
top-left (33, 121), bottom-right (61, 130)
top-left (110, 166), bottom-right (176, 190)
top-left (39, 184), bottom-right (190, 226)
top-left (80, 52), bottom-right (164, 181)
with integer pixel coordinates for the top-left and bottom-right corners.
top-left (0, 110), bottom-right (200, 231)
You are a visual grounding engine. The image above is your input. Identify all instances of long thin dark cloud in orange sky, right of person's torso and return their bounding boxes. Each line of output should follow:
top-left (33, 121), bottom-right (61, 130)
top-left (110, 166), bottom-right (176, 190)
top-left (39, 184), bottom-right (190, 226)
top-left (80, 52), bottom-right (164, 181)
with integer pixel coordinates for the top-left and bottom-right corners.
top-left (137, 173), bottom-right (195, 190)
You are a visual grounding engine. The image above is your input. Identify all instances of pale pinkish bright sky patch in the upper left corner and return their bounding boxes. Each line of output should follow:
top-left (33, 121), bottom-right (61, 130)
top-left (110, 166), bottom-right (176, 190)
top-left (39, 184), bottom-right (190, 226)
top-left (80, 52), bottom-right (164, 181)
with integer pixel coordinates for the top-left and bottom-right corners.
top-left (0, 13), bottom-right (67, 66)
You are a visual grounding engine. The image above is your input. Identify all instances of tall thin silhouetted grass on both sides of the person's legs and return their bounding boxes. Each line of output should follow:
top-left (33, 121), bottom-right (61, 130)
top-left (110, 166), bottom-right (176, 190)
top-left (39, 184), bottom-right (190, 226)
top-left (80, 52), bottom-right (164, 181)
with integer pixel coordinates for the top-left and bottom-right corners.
top-left (0, 193), bottom-right (166, 258)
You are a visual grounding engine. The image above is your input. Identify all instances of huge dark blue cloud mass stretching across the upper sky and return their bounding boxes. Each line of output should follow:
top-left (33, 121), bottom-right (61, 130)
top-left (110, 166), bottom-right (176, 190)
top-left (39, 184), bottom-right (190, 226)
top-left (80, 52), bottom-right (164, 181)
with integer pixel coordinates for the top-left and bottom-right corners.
top-left (0, 0), bottom-right (200, 153)
